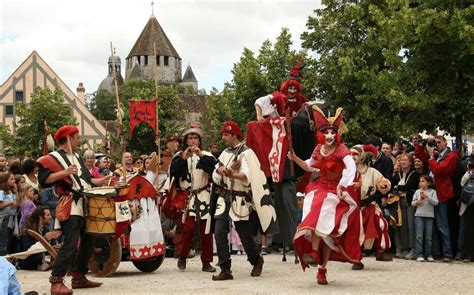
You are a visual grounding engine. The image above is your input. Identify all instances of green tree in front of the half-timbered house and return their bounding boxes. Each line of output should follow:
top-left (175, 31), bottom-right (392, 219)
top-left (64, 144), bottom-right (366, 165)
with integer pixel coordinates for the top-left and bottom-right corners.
top-left (15, 87), bottom-right (77, 157)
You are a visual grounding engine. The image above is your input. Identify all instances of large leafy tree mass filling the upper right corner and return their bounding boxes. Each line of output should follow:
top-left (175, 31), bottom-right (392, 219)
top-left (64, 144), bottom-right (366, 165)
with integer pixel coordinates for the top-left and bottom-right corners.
top-left (302, 0), bottom-right (474, 147)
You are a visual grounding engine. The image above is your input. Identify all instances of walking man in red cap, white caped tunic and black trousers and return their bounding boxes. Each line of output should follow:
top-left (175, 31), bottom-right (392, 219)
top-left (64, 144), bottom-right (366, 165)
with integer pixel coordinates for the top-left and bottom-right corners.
top-left (212, 121), bottom-right (276, 281)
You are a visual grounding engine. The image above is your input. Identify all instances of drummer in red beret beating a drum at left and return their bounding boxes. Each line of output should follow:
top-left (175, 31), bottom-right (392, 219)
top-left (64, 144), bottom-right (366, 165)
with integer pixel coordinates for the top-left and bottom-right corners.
top-left (38, 125), bottom-right (110, 294)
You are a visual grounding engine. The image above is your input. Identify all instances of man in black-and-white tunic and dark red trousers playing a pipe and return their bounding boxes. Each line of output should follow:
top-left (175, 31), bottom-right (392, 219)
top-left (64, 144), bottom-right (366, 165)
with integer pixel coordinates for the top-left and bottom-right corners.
top-left (170, 125), bottom-right (216, 272)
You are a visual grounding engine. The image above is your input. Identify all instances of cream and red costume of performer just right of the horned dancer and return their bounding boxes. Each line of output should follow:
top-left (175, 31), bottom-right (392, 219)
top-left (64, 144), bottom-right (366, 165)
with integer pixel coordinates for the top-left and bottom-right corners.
top-left (354, 167), bottom-right (391, 251)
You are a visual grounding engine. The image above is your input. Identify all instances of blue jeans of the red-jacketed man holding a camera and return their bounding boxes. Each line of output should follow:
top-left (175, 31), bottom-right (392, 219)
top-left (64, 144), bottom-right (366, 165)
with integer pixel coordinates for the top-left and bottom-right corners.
top-left (433, 203), bottom-right (453, 258)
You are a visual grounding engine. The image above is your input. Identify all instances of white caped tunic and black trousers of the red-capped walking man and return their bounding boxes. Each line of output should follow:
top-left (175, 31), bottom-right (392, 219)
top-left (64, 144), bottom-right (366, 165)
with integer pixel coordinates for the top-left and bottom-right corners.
top-left (212, 143), bottom-right (276, 266)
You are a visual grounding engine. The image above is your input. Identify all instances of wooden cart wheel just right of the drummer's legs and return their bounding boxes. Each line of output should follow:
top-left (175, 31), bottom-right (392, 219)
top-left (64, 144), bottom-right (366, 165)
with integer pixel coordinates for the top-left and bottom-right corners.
top-left (88, 238), bottom-right (122, 277)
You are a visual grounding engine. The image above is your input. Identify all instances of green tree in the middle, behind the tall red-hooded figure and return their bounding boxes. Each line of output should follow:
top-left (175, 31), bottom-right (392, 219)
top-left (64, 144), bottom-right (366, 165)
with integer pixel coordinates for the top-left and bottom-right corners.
top-left (206, 28), bottom-right (312, 141)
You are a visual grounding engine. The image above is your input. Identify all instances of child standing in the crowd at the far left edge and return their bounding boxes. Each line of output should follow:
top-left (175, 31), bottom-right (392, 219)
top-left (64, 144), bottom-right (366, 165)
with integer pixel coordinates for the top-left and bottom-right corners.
top-left (0, 172), bottom-right (18, 256)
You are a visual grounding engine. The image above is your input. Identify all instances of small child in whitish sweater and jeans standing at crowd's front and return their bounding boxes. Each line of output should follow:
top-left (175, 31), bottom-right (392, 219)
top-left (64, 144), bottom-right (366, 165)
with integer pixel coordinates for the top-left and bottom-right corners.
top-left (411, 175), bottom-right (438, 262)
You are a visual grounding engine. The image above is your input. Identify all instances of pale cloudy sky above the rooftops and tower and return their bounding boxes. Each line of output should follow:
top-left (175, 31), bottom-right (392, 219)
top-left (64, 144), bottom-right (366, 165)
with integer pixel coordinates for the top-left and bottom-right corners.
top-left (0, 0), bottom-right (320, 93)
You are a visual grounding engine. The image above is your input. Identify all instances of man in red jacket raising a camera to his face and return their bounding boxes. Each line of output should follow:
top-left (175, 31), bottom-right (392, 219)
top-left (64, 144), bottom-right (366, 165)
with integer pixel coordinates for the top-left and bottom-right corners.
top-left (415, 135), bottom-right (458, 262)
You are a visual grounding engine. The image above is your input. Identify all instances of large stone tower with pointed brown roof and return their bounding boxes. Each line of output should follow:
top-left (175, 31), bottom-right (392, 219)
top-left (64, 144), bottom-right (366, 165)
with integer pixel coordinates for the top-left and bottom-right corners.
top-left (125, 15), bottom-right (181, 86)
